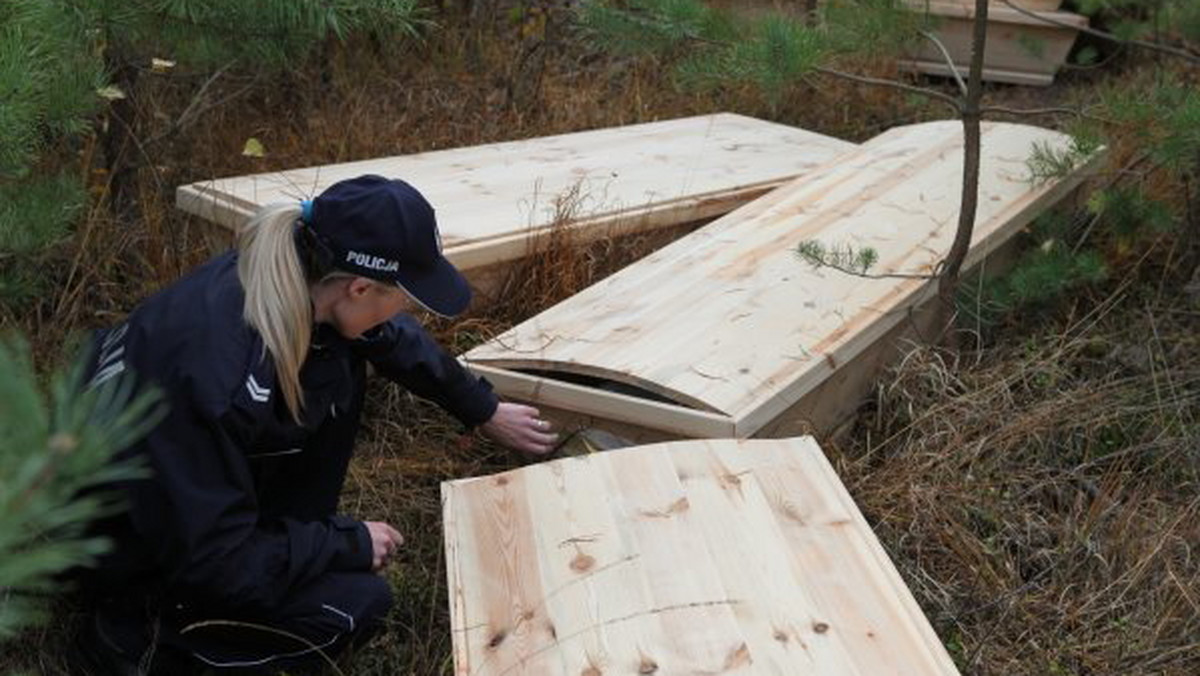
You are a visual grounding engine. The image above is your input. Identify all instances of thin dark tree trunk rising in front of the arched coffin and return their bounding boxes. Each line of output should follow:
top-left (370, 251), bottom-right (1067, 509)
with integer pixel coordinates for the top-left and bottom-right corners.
top-left (937, 0), bottom-right (988, 346)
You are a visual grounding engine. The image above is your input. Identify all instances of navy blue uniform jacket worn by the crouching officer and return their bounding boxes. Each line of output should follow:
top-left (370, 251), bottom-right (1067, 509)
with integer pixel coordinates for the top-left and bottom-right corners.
top-left (92, 253), bottom-right (497, 612)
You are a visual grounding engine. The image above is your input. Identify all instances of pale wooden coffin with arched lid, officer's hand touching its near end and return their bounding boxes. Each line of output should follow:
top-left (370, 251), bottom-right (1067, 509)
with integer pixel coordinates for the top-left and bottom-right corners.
top-left (463, 121), bottom-right (1098, 436)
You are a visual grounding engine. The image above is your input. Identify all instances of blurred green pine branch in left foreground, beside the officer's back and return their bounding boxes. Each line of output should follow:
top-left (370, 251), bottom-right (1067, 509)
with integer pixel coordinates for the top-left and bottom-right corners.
top-left (0, 340), bottom-right (163, 639)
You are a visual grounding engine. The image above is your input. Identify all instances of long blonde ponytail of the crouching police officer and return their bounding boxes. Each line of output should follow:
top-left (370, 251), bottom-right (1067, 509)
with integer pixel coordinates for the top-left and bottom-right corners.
top-left (238, 204), bottom-right (312, 423)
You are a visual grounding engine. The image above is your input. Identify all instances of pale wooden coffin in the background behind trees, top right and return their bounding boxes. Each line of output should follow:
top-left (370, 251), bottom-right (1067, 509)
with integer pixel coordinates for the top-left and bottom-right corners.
top-left (905, 0), bottom-right (1087, 85)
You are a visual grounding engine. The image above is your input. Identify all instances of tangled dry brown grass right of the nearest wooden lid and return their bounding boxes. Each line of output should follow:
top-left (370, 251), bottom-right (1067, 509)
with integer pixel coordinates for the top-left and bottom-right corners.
top-left (827, 273), bottom-right (1200, 674)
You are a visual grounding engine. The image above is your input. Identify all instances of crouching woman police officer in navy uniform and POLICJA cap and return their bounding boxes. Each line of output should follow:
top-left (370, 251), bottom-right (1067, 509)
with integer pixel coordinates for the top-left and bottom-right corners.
top-left (80, 175), bottom-right (554, 674)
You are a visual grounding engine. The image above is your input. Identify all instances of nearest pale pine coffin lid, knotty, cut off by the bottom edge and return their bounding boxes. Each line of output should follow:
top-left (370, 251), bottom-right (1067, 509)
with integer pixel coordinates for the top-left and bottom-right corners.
top-left (443, 437), bottom-right (956, 676)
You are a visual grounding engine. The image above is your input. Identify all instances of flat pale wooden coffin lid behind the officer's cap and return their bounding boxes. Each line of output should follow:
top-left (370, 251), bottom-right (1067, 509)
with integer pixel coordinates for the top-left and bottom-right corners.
top-left (176, 113), bottom-right (853, 269)
